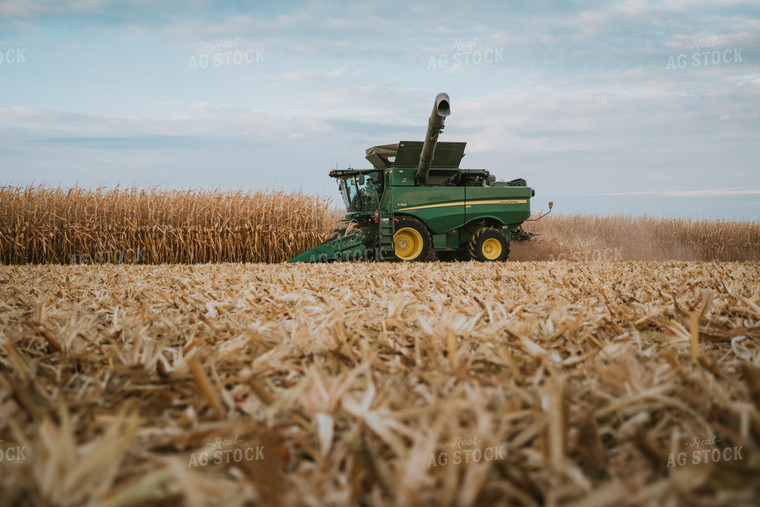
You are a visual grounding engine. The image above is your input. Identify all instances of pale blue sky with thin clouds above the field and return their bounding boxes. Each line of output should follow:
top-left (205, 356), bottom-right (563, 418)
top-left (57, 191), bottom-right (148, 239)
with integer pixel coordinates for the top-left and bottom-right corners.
top-left (0, 0), bottom-right (760, 220)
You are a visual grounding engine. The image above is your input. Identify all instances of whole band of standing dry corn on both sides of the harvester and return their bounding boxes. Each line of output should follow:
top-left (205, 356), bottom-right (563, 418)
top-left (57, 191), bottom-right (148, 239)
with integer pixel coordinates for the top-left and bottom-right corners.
top-left (0, 186), bottom-right (760, 264)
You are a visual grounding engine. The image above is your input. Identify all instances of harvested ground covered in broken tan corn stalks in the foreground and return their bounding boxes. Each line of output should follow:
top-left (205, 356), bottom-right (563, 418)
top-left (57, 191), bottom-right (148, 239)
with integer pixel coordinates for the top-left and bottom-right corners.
top-left (0, 261), bottom-right (760, 506)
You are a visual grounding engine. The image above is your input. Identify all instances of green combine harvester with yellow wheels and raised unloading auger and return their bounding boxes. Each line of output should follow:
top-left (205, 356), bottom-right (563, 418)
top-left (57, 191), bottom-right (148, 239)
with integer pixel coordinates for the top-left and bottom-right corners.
top-left (288, 93), bottom-right (552, 262)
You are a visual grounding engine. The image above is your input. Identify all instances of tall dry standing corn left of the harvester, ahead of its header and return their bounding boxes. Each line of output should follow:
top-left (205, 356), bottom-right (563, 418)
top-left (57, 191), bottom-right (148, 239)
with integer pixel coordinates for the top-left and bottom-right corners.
top-left (0, 186), bottom-right (335, 264)
